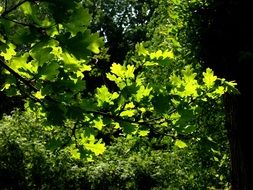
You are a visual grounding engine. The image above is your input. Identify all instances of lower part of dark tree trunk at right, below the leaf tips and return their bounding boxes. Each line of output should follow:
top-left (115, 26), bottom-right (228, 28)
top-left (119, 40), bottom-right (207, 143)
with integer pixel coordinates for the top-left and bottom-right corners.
top-left (225, 95), bottom-right (253, 190)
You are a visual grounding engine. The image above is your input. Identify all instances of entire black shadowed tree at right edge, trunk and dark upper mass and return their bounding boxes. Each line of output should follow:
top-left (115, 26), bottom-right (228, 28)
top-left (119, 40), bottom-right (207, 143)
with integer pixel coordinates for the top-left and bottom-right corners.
top-left (192, 0), bottom-right (253, 190)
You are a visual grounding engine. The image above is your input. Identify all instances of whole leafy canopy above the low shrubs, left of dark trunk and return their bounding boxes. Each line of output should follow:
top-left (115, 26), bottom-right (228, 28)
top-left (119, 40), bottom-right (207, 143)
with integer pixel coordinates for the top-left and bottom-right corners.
top-left (0, 0), bottom-right (241, 189)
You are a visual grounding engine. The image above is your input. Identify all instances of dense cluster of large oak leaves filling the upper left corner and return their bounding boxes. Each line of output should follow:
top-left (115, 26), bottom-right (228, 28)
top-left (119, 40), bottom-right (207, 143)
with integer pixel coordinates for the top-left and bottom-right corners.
top-left (1, 1), bottom-right (104, 157)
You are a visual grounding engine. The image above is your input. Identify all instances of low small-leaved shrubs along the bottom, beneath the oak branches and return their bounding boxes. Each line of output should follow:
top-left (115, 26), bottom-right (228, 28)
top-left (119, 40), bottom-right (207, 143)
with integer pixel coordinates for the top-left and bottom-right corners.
top-left (0, 110), bottom-right (229, 189)
